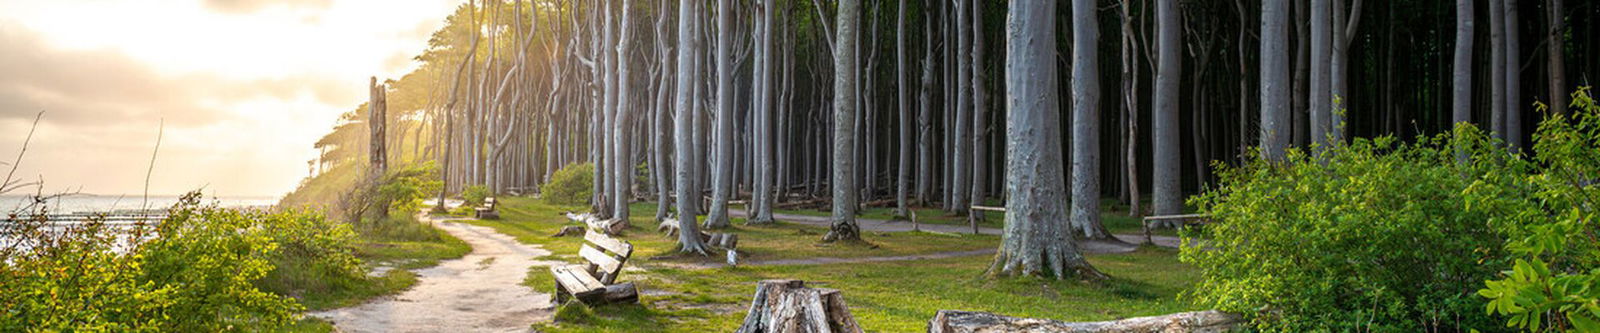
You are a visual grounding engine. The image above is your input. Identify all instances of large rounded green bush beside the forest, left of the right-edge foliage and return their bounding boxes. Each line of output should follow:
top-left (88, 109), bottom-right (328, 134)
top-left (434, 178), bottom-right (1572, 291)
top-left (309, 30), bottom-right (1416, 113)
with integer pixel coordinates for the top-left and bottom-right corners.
top-left (1181, 126), bottom-right (1520, 331)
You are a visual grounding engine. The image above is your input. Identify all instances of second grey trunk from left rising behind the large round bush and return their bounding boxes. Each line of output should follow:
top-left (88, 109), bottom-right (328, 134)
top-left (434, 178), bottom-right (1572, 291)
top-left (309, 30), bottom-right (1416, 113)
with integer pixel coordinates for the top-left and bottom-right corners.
top-left (1306, 0), bottom-right (1333, 149)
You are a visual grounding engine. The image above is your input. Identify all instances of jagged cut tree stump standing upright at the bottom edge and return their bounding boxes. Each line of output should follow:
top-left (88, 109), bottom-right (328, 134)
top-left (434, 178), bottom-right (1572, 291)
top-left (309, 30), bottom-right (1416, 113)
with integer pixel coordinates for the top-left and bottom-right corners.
top-left (738, 280), bottom-right (861, 333)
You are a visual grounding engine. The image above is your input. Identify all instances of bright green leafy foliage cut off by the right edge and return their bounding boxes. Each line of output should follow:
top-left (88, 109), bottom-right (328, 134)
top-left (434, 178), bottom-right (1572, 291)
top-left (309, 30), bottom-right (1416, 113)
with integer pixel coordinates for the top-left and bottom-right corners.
top-left (1474, 88), bottom-right (1600, 331)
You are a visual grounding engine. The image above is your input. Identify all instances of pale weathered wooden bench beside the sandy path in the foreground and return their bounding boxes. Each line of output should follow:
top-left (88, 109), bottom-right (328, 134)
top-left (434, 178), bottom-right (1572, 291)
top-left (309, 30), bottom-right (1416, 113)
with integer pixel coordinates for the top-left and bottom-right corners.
top-left (550, 231), bottom-right (638, 304)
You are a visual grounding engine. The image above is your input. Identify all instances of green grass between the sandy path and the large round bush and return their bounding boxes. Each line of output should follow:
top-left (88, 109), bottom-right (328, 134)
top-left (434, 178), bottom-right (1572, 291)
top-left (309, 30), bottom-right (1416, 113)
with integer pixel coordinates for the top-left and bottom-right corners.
top-left (489, 199), bottom-right (1198, 331)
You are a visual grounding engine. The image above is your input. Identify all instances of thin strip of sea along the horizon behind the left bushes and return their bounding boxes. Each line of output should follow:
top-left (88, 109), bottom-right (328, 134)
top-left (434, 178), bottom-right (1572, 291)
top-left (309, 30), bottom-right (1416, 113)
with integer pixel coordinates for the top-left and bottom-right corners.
top-left (0, 194), bottom-right (278, 215)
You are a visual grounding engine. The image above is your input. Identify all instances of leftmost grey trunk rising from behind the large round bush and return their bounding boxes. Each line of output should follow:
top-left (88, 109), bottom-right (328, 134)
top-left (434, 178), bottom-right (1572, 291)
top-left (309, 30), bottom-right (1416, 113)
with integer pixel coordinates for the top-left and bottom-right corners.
top-left (1261, 2), bottom-right (1290, 160)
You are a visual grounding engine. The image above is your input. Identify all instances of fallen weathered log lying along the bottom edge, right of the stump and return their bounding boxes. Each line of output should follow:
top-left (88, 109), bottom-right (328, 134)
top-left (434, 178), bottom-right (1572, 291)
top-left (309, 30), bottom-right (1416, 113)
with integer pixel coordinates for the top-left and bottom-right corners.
top-left (928, 311), bottom-right (1243, 333)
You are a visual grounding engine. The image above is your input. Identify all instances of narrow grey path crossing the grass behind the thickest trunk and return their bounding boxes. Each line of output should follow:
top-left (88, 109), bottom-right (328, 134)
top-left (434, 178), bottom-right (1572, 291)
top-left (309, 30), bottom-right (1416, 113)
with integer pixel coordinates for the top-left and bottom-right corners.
top-left (728, 210), bottom-right (1181, 252)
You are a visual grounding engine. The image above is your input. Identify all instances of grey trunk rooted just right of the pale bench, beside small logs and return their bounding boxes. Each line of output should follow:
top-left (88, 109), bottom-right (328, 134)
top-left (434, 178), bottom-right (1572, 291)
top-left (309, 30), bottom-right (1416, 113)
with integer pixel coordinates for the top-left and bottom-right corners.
top-left (672, 2), bottom-right (709, 255)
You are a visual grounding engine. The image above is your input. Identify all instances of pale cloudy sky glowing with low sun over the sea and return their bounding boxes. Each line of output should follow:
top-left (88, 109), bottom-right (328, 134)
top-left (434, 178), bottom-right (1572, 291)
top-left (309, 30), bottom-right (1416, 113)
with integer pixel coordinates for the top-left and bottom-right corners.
top-left (0, 0), bottom-right (461, 197)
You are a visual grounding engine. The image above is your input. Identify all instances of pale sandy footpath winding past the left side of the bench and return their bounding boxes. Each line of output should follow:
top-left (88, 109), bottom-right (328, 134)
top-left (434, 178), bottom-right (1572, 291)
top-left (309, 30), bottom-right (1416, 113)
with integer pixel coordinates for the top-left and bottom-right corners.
top-left (309, 216), bottom-right (554, 331)
